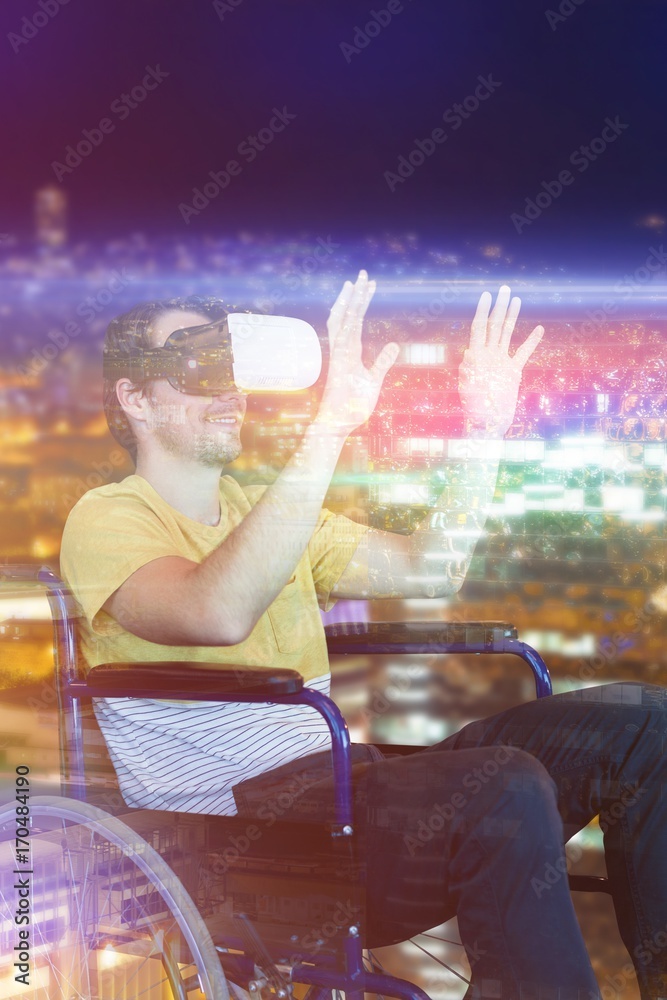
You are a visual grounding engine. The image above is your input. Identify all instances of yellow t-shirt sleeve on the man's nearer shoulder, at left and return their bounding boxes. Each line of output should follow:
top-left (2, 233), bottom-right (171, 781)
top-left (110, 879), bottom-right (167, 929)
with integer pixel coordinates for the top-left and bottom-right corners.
top-left (60, 496), bottom-right (181, 635)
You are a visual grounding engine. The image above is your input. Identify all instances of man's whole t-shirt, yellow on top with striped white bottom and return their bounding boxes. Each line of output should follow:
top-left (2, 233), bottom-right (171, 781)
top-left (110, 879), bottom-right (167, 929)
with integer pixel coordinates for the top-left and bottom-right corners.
top-left (61, 475), bottom-right (366, 815)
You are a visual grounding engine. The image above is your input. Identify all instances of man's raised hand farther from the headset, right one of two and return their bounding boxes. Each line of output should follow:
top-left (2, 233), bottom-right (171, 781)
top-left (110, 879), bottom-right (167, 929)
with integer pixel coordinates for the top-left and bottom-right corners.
top-left (459, 285), bottom-right (544, 437)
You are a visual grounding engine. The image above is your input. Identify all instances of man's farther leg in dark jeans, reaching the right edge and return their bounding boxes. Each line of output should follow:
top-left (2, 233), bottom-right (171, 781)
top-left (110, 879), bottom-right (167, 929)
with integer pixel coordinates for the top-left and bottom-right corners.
top-left (426, 683), bottom-right (667, 997)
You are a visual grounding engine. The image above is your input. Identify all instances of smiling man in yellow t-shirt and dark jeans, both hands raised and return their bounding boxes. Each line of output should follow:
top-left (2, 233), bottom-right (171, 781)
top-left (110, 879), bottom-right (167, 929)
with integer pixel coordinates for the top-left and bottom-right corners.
top-left (62, 271), bottom-right (667, 1000)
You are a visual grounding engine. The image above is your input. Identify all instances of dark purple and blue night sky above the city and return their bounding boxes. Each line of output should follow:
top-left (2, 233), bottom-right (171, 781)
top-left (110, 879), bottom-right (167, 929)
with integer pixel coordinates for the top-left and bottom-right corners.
top-left (0, 0), bottom-right (667, 264)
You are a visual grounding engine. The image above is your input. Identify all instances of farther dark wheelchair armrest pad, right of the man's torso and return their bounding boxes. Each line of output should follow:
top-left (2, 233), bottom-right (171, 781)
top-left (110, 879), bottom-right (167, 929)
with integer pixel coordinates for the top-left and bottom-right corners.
top-left (324, 621), bottom-right (517, 653)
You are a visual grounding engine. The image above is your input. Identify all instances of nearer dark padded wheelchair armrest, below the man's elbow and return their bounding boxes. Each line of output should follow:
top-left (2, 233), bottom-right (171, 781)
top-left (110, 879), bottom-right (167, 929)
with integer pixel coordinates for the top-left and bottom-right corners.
top-left (86, 660), bottom-right (303, 701)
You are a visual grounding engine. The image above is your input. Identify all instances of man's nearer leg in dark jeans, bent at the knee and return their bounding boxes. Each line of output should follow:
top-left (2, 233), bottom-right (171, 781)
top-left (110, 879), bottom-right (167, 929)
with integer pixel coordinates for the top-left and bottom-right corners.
top-left (355, 746), bottom-right (599, 1000)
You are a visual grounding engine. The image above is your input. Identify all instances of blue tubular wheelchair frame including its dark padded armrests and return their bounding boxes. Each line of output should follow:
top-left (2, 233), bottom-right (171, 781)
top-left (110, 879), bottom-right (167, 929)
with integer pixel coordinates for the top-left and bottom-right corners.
top-left (0, 566), bottom-right (606, 1000)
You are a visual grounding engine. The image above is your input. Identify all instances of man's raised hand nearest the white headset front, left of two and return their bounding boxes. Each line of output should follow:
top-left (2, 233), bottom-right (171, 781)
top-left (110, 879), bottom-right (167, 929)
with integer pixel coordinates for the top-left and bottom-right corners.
top-left (317, 271), bottom-right (399, 434)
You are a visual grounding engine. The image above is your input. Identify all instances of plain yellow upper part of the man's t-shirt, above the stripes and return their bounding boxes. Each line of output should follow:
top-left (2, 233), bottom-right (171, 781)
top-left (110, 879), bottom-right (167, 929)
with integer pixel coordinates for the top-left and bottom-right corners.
top-left (61, 475), bottom-right (367, 680)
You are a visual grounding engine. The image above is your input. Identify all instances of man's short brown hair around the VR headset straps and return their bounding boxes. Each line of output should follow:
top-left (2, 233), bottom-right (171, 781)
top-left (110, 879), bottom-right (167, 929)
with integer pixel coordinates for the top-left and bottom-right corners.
top-left (104, 295), bottom-right (227, 465)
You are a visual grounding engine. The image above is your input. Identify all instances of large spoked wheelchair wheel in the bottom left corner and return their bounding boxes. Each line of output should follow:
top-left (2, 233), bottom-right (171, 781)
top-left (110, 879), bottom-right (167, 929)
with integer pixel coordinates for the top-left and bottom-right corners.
top-left (0, 796), bottom-right (229, 1000)
